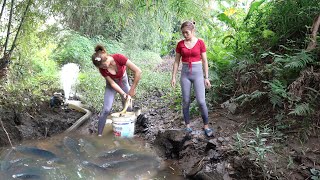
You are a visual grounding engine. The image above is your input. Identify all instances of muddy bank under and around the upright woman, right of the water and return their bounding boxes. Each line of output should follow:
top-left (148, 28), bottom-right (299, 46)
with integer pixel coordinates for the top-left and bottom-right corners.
top-left (125, 93), bottom-right (320, 180)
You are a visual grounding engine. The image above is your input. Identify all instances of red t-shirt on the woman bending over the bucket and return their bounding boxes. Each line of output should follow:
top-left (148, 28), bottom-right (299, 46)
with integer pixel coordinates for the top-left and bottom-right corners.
top-left (99, 54), bottom-right (128, 79)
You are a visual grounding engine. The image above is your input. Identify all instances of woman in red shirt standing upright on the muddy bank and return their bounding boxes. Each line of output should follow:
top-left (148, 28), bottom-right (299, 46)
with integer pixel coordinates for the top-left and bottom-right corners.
top-left (171, 21), bottom-right (213, 136)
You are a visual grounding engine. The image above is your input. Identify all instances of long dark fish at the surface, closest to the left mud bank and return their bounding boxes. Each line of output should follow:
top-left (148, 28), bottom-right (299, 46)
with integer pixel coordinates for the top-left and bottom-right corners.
top-left (13, 146), bottom-right (60, 163)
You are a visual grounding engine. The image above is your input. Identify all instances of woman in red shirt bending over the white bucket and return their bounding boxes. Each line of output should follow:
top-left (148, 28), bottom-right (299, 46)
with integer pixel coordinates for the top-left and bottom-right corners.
top-left (91, 45), bottom-right (141, 136)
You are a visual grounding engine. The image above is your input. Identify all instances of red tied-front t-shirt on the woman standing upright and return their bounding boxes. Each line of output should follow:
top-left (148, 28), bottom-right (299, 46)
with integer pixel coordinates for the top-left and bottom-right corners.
top-left (176, 39), bottom-right (206, 65)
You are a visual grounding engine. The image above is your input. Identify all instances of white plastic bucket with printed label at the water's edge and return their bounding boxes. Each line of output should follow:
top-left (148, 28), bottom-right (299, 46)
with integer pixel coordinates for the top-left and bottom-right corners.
top-left (111, 112), bottom-right (136, 138)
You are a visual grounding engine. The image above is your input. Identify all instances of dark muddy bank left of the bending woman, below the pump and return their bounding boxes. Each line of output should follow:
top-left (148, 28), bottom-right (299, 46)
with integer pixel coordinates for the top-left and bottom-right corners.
top-left (0, 103), bottom-right (84, 147)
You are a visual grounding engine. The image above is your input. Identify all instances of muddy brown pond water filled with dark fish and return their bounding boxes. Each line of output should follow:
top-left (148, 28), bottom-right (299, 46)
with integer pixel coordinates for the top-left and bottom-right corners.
top-left (0, 124), bottom-right (184, 180)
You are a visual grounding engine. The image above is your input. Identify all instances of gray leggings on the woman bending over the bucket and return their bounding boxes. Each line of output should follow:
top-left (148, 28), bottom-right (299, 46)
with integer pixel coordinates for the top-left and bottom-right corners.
top-left (98, 73), bottom-right (130, 134)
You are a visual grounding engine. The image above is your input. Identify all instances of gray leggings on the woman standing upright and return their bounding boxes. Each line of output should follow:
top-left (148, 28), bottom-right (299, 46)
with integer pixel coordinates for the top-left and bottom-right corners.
top-left (180, 63), bottom-right (208, 125)
